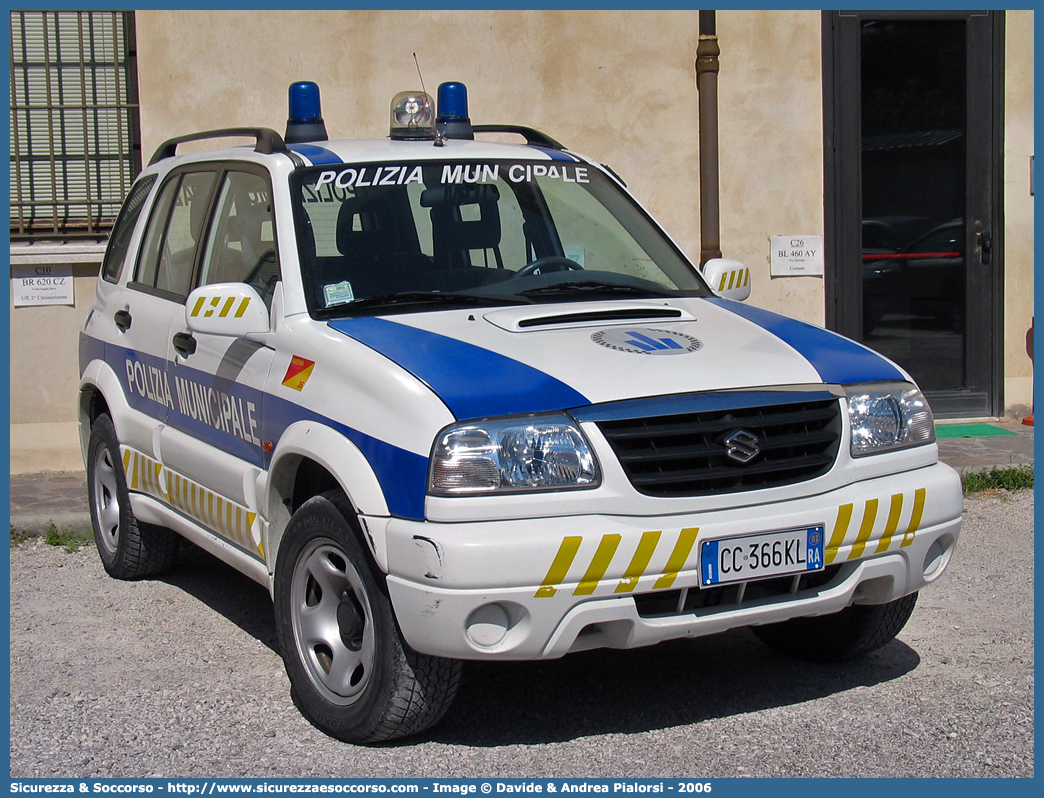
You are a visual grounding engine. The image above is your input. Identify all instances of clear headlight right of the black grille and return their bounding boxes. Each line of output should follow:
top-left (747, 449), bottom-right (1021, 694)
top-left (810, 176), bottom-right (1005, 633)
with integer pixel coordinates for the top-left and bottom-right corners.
top-left (845, 382), bottom-right (935, 457)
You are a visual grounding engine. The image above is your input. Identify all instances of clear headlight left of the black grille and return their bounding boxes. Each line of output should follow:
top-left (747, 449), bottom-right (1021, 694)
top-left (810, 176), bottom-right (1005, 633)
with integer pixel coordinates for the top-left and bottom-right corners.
top-left (428, 415), bottom-right (598, 496)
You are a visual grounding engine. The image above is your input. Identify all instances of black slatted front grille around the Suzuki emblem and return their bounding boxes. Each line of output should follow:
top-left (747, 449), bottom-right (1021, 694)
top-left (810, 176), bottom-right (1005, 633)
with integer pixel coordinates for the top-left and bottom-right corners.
top-left (598, 398), bottom-right (840, 496)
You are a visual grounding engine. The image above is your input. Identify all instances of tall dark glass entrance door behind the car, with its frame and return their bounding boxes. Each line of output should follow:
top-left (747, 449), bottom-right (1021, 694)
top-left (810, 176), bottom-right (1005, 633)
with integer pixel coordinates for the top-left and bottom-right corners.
top-left (825, 11), bottom-right (1003, 418)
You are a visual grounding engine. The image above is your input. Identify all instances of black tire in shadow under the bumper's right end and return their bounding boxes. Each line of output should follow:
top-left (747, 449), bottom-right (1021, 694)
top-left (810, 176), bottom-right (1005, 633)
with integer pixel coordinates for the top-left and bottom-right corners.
top-left (751, 593), bottom-right (917, 662)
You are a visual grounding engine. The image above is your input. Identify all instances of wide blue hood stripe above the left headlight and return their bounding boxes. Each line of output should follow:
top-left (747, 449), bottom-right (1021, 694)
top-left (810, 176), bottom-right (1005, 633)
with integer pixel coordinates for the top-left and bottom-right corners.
top-left (329, 316), bottom-right (591, 421)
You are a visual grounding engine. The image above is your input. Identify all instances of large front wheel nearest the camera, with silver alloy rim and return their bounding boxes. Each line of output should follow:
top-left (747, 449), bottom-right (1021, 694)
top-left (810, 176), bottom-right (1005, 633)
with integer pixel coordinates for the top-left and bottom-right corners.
top-left (275, 491), bottom-right (460, 743)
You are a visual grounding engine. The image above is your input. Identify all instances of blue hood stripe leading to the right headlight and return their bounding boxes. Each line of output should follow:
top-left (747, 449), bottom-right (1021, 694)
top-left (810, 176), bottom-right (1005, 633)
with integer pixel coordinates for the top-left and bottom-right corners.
top-left (704, 297), bottom-right (906, 385)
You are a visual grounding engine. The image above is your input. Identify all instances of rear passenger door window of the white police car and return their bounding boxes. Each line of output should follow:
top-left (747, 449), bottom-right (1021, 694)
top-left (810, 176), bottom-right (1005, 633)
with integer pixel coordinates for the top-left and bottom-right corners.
top-left (136, 171), bottom-right (216, 297)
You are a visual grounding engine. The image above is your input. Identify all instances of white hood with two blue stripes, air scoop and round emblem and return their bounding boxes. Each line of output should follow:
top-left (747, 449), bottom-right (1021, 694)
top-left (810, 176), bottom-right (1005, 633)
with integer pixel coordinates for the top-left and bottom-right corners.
top-left (329, 299), bottom-right (905, 420)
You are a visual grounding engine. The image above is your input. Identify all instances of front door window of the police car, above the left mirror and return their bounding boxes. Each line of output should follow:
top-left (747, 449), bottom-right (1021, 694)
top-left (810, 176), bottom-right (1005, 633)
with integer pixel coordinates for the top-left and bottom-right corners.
top-left (199, 171), bottom-right (279, 307)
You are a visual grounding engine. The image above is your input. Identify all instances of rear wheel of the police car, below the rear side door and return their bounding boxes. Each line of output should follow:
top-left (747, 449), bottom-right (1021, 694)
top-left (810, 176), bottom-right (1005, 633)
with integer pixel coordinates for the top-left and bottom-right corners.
top-left (87, 415), bottom-right (181, 580)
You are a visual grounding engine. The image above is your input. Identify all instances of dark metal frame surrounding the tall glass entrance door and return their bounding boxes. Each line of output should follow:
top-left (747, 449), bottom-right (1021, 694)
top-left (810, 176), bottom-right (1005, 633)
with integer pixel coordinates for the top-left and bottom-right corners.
top-left (822, 10), bottom-right (1004, 418)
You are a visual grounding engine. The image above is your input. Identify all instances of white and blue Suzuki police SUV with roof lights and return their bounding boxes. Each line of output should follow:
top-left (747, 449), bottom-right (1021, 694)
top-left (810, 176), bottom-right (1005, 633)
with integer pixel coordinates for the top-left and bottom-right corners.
top-left (78, 83), bottom-right (962, 743)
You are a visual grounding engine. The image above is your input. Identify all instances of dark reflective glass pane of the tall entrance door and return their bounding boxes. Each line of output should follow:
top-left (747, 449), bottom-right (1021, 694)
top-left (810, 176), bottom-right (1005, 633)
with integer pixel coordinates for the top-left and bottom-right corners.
top-left (860, 20), bottom-right (967, 392)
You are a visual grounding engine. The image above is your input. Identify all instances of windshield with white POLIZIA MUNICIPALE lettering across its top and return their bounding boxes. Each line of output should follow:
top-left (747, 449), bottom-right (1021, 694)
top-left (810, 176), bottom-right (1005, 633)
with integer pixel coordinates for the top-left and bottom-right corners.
top-left (291, 161), bottom-right (710, 318)
